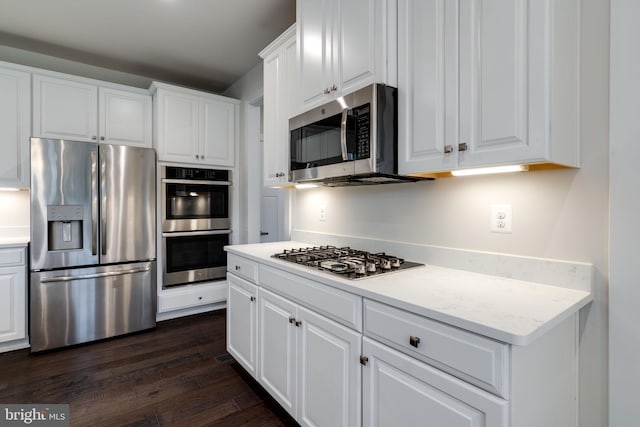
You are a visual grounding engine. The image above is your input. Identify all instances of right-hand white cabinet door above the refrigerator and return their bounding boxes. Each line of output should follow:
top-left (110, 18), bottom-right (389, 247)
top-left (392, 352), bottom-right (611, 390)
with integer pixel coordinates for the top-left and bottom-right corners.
top-left (98, 88), bottom-right (152, 147)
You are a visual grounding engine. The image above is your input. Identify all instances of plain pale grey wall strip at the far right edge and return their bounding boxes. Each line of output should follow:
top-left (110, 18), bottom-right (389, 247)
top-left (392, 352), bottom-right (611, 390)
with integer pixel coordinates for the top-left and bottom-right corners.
top-left (609, 0), bottom-right (640, 427)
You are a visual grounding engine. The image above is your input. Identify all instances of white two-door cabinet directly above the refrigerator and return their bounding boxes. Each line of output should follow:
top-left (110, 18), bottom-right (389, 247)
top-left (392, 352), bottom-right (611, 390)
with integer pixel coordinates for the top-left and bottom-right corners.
top-left (32, 74), bottom-right (152, 147)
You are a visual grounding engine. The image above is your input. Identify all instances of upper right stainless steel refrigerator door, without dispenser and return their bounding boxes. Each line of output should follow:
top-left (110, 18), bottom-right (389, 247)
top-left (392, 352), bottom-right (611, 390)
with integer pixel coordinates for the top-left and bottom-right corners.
top-left (100, 145), bottom-right (156, 264)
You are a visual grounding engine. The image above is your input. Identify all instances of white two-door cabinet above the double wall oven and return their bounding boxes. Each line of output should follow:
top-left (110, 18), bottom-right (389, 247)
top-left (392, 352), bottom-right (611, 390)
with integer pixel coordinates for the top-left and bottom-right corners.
top-left (152, 82), bottom-right (239, 167)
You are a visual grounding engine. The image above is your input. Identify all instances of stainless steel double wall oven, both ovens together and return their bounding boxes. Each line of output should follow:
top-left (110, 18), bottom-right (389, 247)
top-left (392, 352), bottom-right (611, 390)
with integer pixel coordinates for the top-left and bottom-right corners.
top-left (160, 166), bottom-right (231, 288)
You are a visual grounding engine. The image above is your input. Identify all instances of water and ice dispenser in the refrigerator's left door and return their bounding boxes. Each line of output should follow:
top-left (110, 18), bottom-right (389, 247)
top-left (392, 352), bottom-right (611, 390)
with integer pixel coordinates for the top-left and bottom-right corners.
top-left (47, 205), bottom-right (83, 251)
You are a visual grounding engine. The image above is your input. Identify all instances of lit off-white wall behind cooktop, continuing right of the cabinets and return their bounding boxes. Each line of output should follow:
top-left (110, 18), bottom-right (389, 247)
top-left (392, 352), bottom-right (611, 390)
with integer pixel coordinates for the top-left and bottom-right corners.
top-left (292, 0), bottom-right (608, 427)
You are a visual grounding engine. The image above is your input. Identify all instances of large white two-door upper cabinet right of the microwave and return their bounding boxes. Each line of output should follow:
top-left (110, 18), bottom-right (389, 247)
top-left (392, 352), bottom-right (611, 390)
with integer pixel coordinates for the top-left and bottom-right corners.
top-left (398, 0), bottom-right (579, 174)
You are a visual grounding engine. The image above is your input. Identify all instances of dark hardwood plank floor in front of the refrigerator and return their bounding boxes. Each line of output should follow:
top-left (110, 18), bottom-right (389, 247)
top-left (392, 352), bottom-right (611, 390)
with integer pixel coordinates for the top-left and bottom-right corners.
top-left (0, 310), bottom-right (297, 427)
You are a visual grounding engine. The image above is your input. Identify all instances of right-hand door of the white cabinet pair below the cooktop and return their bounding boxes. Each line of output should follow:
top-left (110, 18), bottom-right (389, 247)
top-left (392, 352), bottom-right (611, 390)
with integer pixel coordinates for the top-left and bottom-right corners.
top-left (297, 308), bottom-right (362, 427)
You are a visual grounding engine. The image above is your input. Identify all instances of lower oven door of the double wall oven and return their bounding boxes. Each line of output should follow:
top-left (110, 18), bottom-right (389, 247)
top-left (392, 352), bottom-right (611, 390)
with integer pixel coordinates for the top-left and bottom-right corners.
top-left (162, 230), bottom-right (231, 288)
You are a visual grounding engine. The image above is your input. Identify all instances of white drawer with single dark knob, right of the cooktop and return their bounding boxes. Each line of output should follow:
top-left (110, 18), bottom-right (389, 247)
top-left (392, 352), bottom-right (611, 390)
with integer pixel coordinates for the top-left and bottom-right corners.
top-left (364, 300), bottom-right (509, 398)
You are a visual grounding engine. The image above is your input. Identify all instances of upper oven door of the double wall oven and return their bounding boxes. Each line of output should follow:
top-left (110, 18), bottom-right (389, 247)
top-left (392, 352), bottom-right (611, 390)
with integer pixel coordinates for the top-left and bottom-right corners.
top-left (162, 178), bottom-right (231, 233)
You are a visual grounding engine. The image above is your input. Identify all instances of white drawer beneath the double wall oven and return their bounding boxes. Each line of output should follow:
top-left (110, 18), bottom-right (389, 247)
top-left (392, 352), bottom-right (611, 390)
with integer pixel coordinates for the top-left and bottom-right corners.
top-left (158, 281), bottom-right (227, 313)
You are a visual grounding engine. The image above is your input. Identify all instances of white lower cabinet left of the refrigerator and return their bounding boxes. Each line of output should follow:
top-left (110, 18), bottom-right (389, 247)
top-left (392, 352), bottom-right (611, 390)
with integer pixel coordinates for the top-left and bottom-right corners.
top-left (0, 248), bottom-right (28, 351)
